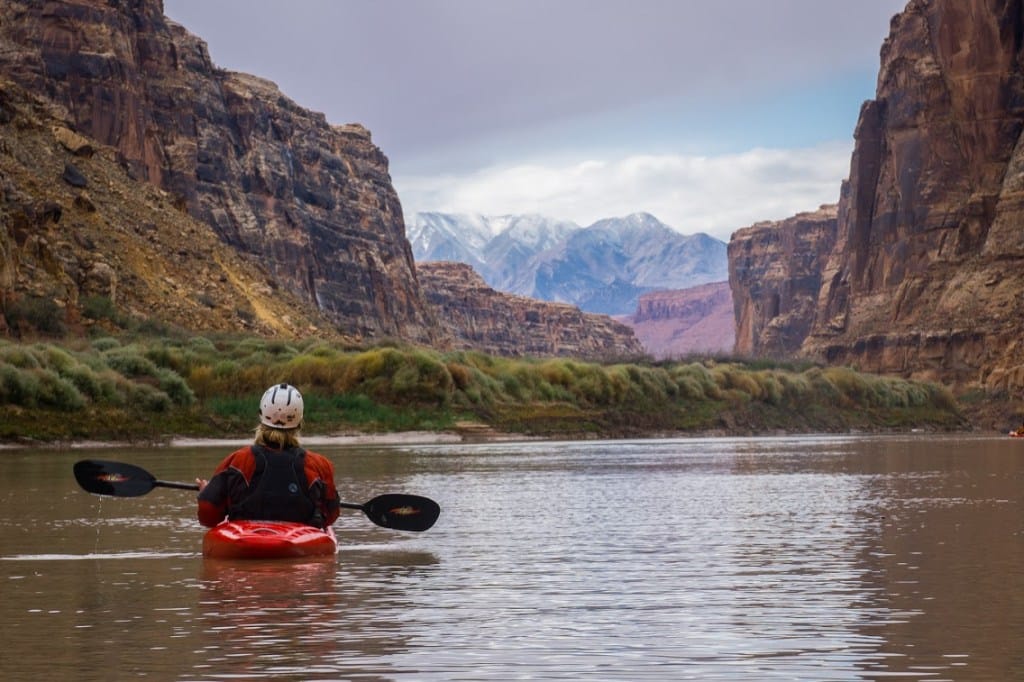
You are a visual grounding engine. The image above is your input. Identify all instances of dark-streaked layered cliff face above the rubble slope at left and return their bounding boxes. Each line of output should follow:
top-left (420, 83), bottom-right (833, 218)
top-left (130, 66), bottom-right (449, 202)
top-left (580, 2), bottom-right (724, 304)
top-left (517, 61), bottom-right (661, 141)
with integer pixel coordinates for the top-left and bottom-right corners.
top-left (0, 0), bottom-right (437, 342)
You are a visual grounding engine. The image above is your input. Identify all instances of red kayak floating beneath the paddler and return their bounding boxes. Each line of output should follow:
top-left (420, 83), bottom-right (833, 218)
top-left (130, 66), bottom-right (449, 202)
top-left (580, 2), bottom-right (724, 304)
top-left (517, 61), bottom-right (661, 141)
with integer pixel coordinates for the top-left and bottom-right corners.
top-left (203, 521), bottom-right (338, 559)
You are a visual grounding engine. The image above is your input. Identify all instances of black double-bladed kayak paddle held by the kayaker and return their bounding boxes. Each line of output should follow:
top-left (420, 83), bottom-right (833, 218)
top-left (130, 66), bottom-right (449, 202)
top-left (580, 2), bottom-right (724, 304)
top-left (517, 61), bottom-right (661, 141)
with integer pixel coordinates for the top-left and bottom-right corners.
top-left (75, 460), bottom-right (441, 531)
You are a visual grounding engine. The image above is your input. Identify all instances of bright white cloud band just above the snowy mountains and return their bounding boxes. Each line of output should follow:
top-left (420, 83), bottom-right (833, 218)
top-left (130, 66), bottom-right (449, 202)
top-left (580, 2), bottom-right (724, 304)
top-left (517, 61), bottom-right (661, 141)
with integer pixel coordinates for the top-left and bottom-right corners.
top-left (394, 142), bottom-right (852, 241)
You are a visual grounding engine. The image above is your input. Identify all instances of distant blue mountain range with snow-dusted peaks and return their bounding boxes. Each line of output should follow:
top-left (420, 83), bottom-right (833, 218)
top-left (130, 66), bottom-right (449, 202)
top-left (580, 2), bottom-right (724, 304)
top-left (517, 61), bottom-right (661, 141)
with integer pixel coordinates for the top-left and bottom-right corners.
top-left (407, 213), bottom-right (729, 315)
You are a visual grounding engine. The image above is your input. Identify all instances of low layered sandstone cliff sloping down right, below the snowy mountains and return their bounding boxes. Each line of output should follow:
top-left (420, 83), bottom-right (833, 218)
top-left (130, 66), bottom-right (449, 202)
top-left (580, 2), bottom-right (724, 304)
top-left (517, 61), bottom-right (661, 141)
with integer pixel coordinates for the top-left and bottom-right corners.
top-left (418, 261), bottom-right (643, 359)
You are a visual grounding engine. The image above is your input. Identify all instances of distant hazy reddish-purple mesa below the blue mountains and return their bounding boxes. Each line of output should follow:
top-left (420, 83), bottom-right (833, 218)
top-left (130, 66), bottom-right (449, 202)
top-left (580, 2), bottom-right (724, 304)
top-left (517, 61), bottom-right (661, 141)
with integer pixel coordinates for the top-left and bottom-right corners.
top-left (623, 282), bottom-right (736, 358)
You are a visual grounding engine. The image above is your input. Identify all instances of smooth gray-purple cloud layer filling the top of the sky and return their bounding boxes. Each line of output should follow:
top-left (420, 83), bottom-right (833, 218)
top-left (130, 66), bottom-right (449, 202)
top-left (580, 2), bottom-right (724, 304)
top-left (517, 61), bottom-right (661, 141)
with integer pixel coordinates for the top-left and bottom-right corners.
top-left (165, 0), bottom-right (904, 160)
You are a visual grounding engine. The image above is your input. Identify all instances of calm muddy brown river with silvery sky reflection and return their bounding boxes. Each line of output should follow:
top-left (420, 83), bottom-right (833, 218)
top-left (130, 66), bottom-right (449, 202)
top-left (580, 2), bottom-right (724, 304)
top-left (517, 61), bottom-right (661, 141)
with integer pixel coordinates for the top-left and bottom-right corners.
top-left (0, 435), bottom-right (1024, 681)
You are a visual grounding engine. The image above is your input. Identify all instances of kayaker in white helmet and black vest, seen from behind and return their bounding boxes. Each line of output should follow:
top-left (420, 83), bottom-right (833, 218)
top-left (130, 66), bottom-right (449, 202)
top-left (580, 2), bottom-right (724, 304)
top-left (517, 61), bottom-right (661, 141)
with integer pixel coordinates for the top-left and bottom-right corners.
top-left (196, 384), bottom-right (340, 528)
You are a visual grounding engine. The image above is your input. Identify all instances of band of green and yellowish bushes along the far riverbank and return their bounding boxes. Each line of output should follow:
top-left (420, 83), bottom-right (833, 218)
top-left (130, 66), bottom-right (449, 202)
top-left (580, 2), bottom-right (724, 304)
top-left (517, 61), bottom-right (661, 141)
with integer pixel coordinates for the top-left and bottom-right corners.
top-left (0, 336), bottom-right (968, 443)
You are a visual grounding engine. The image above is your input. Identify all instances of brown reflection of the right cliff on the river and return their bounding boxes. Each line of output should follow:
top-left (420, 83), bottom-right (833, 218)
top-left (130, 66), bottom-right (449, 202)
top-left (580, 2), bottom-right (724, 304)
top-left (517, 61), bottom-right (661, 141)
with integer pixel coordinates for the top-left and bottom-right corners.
top-left (847, 439), bottom-right (1024, 680)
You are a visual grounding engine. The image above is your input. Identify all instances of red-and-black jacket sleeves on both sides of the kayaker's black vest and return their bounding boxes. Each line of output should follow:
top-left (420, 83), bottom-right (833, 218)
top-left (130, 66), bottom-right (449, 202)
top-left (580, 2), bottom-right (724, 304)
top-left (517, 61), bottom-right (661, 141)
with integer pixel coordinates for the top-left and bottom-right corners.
top-left (197, 445), bottom-right (341, 527)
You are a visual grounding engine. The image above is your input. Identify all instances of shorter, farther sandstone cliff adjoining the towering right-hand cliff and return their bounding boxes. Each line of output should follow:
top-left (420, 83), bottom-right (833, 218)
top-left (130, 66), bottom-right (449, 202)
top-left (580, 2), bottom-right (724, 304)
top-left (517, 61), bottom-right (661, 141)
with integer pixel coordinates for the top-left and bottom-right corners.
top-left (728, 206), bottom-right (838, 358)
